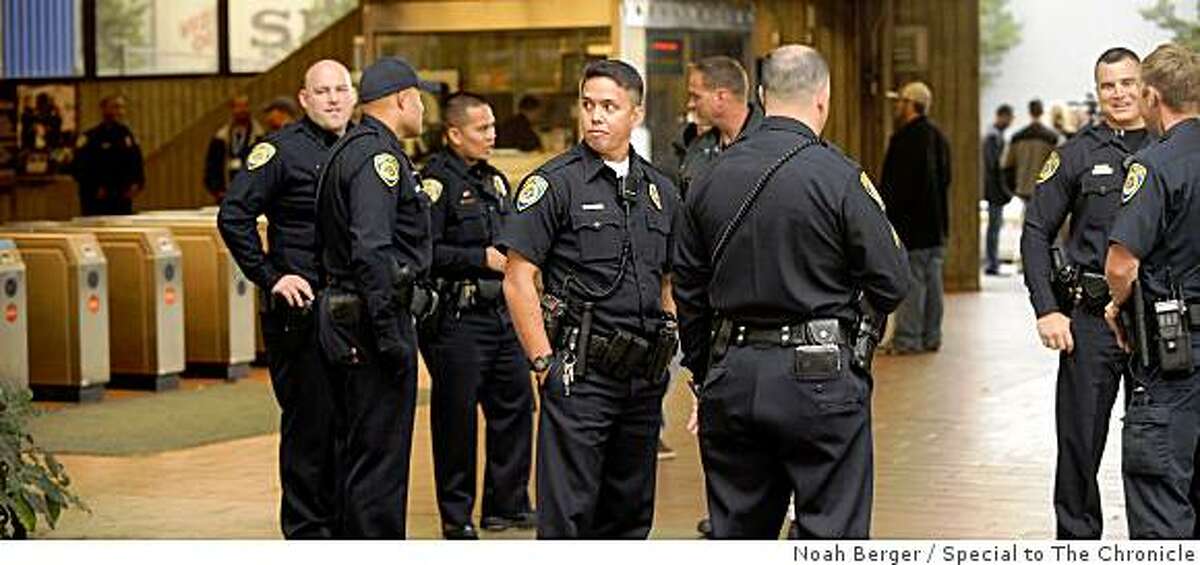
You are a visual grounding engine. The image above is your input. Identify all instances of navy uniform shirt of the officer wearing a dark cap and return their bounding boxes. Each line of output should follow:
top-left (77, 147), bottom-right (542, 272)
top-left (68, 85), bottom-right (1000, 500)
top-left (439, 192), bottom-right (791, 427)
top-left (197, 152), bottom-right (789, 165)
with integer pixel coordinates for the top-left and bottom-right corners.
top-left (317, 115), bottom-right (433, 351)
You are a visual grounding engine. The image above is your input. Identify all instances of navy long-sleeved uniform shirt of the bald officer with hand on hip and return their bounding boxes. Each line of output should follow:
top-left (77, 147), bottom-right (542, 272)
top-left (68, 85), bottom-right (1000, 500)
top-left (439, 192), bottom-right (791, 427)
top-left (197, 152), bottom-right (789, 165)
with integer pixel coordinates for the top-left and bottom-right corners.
top-left (217, 118), bottom-right (337, 290)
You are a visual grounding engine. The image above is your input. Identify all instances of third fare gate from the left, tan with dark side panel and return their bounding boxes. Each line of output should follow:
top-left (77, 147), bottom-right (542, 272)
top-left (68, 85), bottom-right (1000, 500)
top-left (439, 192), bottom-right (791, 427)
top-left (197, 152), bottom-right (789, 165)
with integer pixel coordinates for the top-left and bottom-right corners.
top-left (5, 222), bottom-right (186, 391)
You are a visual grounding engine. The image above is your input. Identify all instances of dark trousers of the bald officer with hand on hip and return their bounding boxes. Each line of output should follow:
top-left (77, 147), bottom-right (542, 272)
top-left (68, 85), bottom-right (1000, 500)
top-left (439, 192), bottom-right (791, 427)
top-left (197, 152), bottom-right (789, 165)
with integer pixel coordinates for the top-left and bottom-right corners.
top-left (260, 307), bottom-right (337, 540)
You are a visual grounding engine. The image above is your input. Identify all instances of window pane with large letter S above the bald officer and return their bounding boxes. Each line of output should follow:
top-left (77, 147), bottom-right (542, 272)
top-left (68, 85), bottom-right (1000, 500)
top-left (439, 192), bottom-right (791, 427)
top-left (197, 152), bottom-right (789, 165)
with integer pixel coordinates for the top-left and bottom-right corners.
top-left (229, 0), bottom-right (358, 72)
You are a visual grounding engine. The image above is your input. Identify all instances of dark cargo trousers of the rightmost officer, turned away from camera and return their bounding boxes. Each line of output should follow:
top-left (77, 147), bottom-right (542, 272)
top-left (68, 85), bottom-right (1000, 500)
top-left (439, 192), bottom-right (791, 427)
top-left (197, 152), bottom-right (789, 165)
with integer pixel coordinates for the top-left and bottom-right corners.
top-left (1121, 345), bottom-right (1200, 540)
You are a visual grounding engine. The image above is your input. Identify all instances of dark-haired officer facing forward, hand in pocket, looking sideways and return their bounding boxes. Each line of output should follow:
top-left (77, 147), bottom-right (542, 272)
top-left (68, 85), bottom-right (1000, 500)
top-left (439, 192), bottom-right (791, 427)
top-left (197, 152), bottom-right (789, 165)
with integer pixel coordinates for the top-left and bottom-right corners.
top-left (502, 60), bottom-right (678, 539)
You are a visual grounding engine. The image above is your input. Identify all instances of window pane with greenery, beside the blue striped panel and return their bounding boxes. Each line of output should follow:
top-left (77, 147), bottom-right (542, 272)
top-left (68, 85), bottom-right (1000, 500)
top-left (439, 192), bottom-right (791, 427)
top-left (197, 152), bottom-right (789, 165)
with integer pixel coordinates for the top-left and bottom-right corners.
top-left (96, 0), bottom-right (218, 77)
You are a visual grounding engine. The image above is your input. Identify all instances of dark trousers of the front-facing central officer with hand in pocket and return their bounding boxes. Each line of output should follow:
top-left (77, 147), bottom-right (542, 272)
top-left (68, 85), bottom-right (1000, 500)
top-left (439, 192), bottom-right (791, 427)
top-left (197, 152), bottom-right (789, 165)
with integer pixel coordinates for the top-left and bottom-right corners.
top-left (538, 357), bottom-right (668, 539)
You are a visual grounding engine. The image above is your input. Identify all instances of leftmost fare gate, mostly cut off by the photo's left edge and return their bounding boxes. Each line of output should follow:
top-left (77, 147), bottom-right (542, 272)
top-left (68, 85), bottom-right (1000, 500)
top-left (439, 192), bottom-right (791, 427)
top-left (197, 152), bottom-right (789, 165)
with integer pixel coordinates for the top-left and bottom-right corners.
top-left (0, 239), bottom-right (29, 389)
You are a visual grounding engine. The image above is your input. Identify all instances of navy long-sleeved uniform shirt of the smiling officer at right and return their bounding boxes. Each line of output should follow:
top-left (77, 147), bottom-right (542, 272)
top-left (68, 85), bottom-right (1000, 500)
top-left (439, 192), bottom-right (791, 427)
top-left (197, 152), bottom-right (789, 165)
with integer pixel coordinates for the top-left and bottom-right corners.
top-left (1021, 124), bottom-right (1151, 318)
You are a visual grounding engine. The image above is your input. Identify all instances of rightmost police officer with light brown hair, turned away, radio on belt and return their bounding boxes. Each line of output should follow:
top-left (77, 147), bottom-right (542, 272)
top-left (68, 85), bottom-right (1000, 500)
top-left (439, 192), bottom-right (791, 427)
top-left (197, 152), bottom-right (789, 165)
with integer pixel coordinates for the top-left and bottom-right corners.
top-left (1105, 43), bottom-right (1200, 539)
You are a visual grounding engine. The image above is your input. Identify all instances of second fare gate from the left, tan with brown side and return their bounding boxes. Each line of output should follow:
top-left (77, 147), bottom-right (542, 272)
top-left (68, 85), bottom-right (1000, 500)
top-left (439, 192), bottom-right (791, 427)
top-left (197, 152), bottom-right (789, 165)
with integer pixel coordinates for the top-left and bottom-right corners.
top-left (0, 227), bottom-right (109, 401)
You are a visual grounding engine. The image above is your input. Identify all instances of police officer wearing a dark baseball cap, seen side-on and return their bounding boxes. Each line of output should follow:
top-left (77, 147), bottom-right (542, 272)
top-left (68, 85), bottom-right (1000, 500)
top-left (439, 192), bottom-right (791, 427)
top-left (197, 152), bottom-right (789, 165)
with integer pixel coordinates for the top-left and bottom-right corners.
top-left (317, 58), bottom-right (433, 539)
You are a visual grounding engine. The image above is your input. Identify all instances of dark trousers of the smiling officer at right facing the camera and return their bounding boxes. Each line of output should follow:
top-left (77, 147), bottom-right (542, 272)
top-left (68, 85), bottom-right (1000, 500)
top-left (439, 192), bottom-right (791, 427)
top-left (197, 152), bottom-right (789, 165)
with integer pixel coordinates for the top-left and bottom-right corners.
top-left (1054, 308), bottom-right (1129, 540)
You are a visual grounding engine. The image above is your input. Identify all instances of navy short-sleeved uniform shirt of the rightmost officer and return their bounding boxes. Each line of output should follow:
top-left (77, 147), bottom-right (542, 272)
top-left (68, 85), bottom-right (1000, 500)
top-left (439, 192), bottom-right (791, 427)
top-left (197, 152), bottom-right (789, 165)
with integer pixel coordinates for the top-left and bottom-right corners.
top-left (1109, 118), bottom-right (1200, 301)
